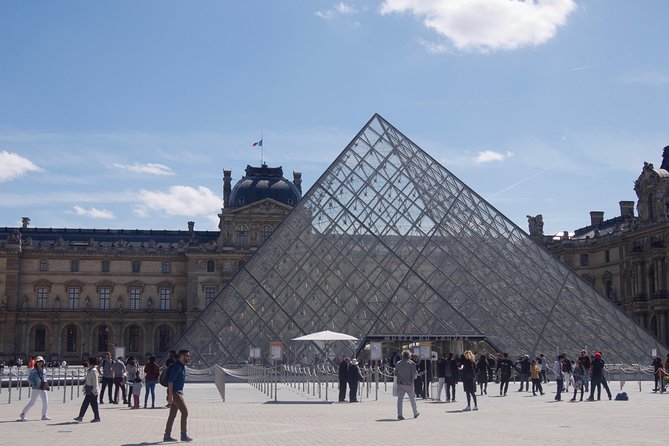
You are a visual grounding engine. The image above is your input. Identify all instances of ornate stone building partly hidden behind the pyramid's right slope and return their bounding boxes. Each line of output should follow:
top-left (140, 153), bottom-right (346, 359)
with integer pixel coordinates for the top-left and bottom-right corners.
top-left (528, 146), bottom-right (669, 344)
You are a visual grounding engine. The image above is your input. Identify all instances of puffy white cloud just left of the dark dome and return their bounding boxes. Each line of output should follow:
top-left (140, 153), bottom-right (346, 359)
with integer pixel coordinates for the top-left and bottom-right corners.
top-left (134, 186), bottom-right (223, 217)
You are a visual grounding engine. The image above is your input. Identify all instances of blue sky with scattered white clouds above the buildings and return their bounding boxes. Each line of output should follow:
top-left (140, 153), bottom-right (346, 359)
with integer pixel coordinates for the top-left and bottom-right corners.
top-left (0, 0), bottom-right (669, 234)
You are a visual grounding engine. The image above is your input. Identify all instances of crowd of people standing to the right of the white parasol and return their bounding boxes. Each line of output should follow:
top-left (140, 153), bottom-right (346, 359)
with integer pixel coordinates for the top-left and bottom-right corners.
top-left (339, 350), bottom-right (648, 420)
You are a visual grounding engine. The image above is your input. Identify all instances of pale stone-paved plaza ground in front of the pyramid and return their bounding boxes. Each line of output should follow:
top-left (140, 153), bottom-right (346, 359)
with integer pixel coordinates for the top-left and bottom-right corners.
top-left (0, 381), bottom-right (669, 446)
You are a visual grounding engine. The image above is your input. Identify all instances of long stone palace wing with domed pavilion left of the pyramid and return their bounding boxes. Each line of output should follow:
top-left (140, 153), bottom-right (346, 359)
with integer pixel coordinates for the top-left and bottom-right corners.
top-left (0, 164), bottom-right (302, 362)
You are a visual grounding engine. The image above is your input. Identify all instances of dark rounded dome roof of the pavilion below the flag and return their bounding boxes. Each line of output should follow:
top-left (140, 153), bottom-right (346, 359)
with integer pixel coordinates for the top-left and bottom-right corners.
top-left (228, 164), bottom-right (302, 208)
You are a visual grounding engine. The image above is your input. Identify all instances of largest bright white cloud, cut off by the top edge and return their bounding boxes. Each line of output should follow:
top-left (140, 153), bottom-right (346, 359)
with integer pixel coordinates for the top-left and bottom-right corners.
top-left (380, 0), bottom-right (576, 52)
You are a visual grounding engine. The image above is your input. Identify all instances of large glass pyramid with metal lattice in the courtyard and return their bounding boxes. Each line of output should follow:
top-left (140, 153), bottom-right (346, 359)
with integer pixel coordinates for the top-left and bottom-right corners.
top-left (175, 115), bottom-right (666, 367)
